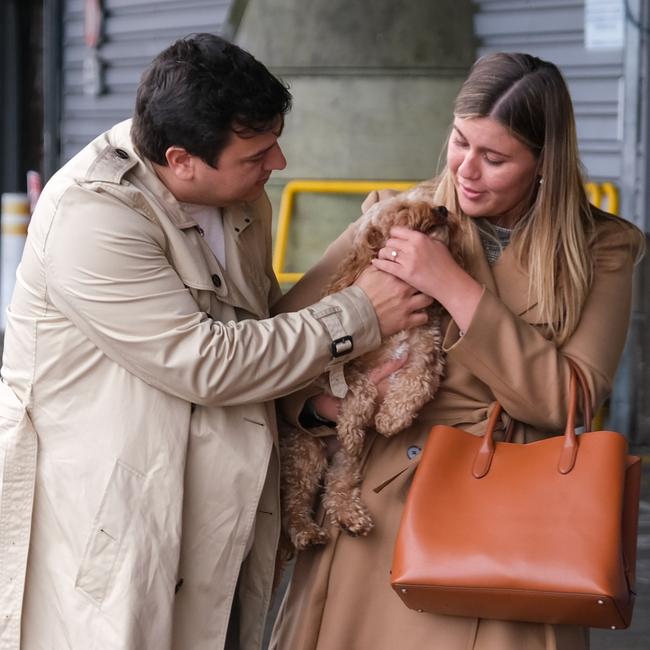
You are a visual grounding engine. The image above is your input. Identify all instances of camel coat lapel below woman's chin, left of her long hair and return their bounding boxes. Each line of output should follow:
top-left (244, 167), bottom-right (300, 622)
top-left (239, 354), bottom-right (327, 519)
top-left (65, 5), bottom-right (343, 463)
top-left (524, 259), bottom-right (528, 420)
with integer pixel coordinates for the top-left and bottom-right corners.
top-left (469, 234), bottom-right (538, 316)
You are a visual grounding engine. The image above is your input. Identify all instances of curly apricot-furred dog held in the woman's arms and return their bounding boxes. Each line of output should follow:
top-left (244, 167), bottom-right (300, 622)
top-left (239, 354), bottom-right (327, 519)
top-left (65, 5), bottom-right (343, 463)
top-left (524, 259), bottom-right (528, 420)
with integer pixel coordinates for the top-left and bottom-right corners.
top-left (280, 183), bottom-right (461, 550)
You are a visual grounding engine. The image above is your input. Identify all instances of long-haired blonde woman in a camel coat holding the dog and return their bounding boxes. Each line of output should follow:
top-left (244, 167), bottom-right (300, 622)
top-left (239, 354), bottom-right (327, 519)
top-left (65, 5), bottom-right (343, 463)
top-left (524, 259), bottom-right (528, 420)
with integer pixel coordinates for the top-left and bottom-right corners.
top-left (272, 53), bottom-right (643, 650)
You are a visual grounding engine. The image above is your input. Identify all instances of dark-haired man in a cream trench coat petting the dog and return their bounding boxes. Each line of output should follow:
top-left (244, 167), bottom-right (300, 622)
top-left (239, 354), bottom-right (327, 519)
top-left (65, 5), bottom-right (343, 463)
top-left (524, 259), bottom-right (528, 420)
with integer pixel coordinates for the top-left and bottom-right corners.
top-left (0, 34), bottom-right (429, 650)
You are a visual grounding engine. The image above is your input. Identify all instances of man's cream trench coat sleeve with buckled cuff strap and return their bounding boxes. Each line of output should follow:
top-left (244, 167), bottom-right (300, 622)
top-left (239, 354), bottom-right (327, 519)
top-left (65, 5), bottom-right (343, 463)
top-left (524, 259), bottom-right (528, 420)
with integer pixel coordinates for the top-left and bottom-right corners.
top-left (42, 187), bottom-right (380, 405)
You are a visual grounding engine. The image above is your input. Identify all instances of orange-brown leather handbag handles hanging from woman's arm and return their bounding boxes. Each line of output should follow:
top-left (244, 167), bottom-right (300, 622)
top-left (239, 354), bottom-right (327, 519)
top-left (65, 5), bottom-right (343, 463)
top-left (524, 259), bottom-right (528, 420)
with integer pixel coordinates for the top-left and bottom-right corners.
top-left (472, 359), bottom-right (592, 478)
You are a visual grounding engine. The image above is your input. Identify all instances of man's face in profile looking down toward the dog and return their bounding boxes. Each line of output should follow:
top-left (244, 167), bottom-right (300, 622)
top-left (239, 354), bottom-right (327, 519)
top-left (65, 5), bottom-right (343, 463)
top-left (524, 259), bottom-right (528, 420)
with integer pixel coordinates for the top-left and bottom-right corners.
top-left (190, 118), bottom-right (287, 208)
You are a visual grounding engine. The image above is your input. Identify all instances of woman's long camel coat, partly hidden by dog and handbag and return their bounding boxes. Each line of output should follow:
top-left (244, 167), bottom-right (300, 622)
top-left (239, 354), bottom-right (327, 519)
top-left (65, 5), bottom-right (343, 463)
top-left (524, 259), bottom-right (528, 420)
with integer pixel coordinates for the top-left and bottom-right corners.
top-left (271, 200), bottom-right (636, 650)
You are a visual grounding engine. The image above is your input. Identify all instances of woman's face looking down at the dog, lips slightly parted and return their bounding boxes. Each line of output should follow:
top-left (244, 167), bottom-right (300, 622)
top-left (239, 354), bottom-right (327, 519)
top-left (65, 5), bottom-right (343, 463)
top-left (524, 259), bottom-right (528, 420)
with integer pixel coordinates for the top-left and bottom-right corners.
top-left (447, 117), bottom-right (539, 228)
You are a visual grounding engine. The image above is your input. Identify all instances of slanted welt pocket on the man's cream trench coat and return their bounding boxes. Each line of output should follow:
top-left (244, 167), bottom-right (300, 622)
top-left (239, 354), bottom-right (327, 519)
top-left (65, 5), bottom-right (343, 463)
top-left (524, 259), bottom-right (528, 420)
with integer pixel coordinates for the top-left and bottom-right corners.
top-left (75, 460), bottom-right (145, 605)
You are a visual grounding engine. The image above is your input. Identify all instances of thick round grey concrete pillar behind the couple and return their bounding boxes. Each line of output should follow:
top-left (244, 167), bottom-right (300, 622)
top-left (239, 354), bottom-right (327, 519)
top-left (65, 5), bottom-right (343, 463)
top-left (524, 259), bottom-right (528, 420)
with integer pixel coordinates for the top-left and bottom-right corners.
top-left (235, 0), bottom-right (475, 271)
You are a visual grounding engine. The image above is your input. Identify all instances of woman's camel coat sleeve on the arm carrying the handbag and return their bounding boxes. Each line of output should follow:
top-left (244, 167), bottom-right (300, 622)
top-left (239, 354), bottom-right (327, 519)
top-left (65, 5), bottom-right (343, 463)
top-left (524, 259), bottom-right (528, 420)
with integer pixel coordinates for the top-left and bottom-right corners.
top-left (444, 222), bottom-right (636, 430)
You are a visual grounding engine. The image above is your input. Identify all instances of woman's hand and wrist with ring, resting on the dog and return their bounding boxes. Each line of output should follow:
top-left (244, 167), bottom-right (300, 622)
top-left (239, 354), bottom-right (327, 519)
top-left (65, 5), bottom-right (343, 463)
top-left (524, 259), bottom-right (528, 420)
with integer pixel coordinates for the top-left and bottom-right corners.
top-left (372, 226), bottom-right (483, 331)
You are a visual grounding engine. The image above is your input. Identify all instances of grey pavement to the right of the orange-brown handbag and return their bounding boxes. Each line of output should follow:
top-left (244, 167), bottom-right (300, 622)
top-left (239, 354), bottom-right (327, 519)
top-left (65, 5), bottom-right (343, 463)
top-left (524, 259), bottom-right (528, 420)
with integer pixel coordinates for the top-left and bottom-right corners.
top-left (591, 447), bottom-right (650, 650)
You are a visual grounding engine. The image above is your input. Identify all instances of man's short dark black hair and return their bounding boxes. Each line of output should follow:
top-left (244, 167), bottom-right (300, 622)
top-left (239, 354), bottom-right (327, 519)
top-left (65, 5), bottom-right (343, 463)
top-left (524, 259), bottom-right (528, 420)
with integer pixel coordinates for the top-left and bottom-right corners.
top-left (131, 34), bottom-right (291, 166)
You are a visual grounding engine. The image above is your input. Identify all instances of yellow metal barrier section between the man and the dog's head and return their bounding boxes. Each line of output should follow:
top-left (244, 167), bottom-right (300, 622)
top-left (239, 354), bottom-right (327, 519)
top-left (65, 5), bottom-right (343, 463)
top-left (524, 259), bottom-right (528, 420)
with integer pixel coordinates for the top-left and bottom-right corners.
top-left (273, 180), bottom-right (415, 284)
